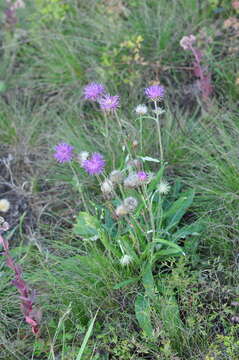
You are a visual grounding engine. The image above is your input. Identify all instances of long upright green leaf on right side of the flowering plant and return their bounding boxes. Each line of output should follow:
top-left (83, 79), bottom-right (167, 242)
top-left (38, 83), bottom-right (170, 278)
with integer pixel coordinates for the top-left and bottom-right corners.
top-left (163, 190), bottom-right (195, 231)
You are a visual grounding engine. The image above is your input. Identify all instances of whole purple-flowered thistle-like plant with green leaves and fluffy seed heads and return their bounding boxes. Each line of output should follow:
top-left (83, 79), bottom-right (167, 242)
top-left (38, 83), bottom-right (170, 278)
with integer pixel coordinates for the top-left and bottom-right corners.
top-left (54, 83), bottom-right (201, 336)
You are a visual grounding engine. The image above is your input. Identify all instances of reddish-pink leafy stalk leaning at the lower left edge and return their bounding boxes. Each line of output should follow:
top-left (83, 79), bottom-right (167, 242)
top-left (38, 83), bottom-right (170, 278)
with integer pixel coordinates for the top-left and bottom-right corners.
top-left (0, 218), bottom-right (41, 336)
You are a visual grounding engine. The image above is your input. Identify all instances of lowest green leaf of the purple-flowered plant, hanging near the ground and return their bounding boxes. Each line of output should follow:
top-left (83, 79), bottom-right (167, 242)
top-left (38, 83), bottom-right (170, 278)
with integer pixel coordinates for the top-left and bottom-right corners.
top-left (135, 295), bottom-right (153, 337)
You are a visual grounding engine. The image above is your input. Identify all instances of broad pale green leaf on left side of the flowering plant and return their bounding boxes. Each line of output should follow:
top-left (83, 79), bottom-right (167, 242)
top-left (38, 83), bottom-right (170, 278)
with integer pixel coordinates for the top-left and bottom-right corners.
top-left (73, 211), bottom-right (100, 238)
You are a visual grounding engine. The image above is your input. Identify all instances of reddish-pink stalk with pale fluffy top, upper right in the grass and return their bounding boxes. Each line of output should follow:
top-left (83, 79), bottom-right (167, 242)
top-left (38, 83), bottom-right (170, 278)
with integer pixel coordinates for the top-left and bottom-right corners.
top-left (180, 35), bottom-right (213, 101)
